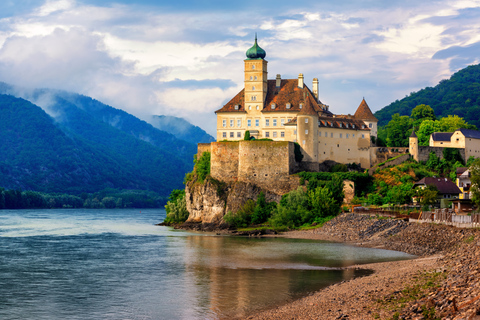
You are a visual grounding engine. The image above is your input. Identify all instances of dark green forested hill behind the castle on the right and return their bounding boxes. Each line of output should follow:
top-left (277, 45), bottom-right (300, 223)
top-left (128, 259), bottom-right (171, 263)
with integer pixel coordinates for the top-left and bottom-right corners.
top-left (375, 65), bottom-right (480, 128)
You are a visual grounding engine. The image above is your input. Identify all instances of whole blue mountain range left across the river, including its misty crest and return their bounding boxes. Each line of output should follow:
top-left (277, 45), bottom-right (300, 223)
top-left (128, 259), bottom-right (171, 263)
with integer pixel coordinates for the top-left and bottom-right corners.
top-left (0, 87), bottom-right (196, 196)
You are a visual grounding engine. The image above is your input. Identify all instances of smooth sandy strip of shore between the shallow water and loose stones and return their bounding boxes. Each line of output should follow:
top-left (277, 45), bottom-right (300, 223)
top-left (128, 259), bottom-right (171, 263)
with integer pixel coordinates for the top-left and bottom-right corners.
top-left (247, 255), bottom-right (440, 320)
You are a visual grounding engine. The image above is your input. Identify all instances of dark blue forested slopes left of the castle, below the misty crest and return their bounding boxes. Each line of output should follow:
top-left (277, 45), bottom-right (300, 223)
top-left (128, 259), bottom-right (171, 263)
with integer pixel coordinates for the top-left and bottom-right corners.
top-left (0, 95), bottom-right (192, 196)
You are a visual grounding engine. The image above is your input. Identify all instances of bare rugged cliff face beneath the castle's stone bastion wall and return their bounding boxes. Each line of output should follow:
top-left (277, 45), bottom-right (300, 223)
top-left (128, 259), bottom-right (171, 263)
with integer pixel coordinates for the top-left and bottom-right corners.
top-left (185, 177), bottom-right (298, 224)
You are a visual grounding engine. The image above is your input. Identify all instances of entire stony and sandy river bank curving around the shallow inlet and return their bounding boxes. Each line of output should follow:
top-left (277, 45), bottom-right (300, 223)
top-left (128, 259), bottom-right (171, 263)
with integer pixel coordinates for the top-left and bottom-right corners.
top-left (242, 214), bottom-right (480, 320)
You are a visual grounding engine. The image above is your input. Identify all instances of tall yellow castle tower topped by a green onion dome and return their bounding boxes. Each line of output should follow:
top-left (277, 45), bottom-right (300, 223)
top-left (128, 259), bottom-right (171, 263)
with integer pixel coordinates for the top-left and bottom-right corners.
top-left (244, 34), bottom-right (268, 120)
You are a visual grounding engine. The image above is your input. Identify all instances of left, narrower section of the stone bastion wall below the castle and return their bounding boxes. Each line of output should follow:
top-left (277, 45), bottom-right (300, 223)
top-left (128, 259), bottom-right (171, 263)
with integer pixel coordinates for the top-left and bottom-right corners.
top-left (210, 141), bottom-right (239, 182)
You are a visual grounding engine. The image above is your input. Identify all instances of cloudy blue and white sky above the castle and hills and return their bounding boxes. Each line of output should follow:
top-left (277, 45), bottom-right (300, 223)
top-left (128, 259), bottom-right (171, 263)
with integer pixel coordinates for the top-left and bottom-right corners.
top-left (0, 0), bottom-right (480, 135)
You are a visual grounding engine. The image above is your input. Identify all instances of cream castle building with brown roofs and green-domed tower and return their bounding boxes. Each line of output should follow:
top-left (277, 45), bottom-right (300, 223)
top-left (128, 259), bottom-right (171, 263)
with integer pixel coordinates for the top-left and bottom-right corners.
top-left (216, 39), bottom-right (378, 171)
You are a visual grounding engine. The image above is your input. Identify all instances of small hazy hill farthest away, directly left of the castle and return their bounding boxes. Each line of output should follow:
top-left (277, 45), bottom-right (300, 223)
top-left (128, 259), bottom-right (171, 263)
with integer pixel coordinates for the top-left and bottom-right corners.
top-left (150, 116), bottom-right (215, 144)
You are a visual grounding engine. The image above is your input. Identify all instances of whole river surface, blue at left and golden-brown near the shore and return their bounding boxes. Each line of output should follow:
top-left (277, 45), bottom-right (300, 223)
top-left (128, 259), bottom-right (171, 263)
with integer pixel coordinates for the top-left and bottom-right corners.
top-left (0, 209), bottom-right (412, 320)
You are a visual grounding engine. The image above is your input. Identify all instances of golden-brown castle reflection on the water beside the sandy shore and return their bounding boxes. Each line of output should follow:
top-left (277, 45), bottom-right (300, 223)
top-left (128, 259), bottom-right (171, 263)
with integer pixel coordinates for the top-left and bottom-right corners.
top-left (179, 236), bottom-right (376, 318)
